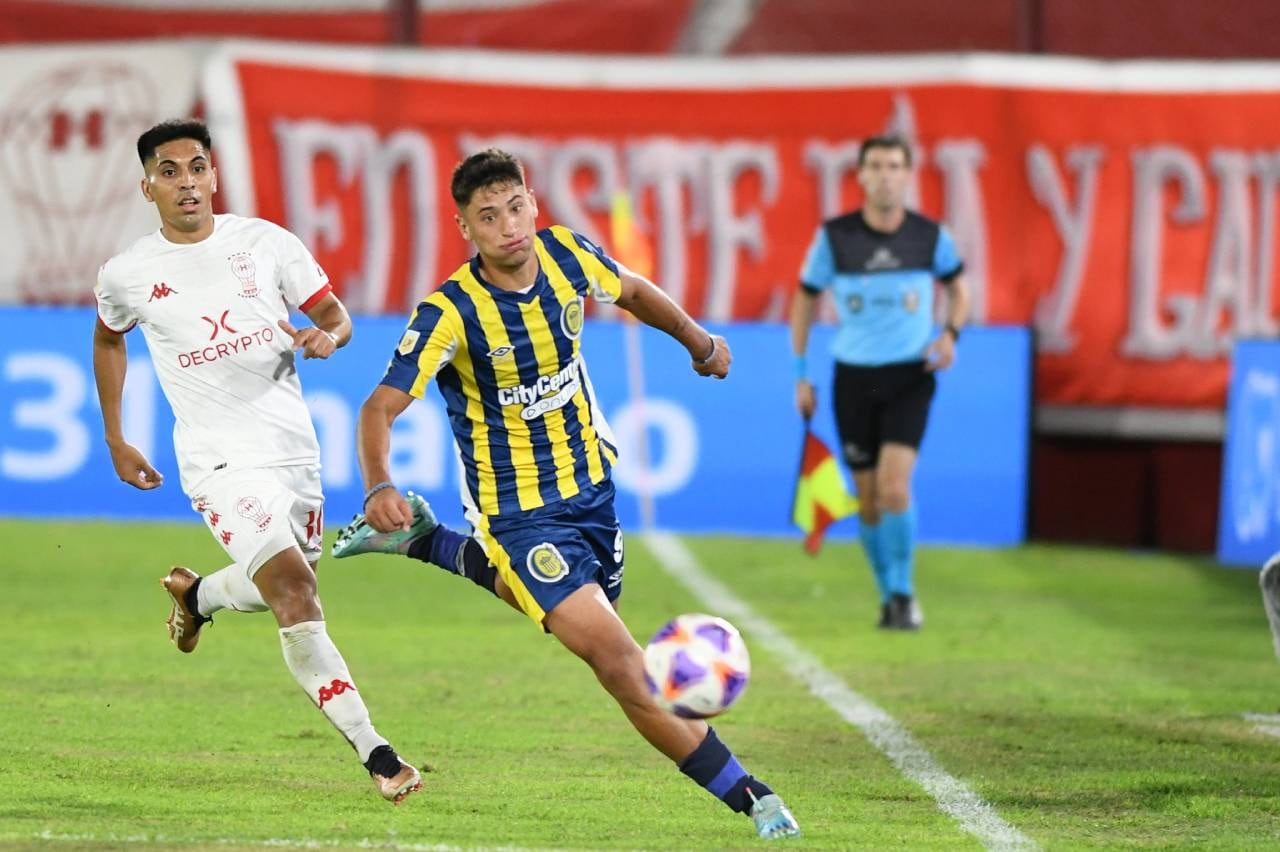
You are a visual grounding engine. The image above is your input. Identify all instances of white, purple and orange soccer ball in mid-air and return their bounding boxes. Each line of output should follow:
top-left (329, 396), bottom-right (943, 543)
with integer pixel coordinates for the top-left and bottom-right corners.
top-left (644, 614), bottom-right (751, 719)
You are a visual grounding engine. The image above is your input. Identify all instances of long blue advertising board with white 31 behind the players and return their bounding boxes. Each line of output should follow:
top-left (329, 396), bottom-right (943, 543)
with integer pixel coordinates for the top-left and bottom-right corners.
top-left (0, 308), bottom-right (1032, 545)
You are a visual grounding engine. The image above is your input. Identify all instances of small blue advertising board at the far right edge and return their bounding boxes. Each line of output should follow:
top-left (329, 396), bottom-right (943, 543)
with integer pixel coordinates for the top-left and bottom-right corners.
top-left (1217, 340), bottom-right (1280, 568)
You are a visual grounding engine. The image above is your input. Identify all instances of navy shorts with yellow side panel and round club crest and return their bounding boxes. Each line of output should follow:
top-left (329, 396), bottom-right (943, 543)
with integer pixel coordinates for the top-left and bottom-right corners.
top-left (480, 480), bottom-right (622, 626)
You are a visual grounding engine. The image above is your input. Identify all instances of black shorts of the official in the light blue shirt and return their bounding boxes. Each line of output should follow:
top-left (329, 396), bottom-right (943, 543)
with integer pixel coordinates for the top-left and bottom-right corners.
top-left (835, 361), bottom-right (937, 471)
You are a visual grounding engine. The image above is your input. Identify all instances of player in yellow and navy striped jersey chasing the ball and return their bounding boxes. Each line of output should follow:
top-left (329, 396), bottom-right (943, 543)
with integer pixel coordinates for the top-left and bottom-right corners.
top-left (334, 148), bottom-right (799, 839)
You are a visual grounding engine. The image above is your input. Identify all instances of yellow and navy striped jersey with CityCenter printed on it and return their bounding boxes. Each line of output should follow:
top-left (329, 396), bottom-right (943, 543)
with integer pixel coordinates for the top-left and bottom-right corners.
top-left (381, 225), bottom-right (622, 517)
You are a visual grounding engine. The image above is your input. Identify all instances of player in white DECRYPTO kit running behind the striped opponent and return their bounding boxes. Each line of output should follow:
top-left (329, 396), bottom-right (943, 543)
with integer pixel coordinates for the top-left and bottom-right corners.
top-left (93, 120), bottom-right (422, 805)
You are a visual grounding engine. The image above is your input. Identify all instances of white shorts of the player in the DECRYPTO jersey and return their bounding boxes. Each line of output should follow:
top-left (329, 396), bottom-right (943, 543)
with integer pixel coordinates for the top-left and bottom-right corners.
top-left (191, 464), bottom-right (324, 577)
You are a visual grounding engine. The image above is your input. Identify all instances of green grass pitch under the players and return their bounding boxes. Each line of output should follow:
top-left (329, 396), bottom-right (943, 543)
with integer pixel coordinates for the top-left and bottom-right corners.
top-left (0, 521), bottom-right (1280, 849)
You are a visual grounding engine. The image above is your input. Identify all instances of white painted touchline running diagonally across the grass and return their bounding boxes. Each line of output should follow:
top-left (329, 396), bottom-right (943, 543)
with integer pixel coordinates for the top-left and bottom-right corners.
top-left (644, 532), bottom-right (1037, 849)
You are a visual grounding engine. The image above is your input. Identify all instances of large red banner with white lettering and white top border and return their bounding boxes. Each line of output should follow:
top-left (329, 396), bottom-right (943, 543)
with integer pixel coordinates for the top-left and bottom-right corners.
top-left (215, 46), bottom-right (1280, 408)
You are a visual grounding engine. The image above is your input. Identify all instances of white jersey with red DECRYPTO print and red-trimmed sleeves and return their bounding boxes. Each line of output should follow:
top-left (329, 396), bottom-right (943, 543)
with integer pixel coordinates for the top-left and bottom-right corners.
top-left (95, 215), bottom-right (330, 496)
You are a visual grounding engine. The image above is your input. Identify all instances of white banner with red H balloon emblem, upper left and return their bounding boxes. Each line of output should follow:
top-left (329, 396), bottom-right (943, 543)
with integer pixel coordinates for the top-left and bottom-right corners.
top-left (0, 42), bottom-right (209, 304)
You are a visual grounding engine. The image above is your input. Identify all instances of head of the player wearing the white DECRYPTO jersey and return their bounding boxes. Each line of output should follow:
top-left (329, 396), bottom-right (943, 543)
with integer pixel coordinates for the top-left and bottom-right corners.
top-left (142, 139), bottom-right (218, 235)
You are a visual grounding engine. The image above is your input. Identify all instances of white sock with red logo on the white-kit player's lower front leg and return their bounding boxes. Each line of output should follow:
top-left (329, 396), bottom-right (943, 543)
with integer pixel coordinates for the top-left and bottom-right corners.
top-left (280, 622), bottom-right (388, 762)
